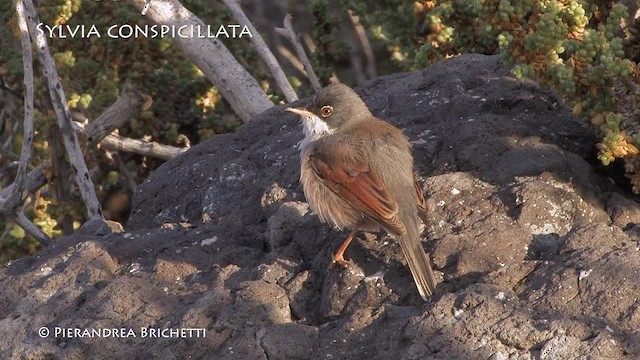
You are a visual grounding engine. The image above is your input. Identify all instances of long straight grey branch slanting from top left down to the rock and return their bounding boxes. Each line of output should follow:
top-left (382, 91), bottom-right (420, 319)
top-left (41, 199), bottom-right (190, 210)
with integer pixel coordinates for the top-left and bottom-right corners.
top-left (22, 0), bottom-right (103, 219)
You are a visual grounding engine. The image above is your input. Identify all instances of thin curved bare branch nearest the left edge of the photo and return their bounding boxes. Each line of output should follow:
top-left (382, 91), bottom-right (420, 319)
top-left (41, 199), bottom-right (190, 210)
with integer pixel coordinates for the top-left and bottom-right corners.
top-left (0, 0), bottom-right (35, 212)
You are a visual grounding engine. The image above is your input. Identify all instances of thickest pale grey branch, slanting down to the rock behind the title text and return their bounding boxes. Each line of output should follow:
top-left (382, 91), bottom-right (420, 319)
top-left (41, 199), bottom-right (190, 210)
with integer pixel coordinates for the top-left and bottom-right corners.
top-left (129, 0), bottom-right (273, 122)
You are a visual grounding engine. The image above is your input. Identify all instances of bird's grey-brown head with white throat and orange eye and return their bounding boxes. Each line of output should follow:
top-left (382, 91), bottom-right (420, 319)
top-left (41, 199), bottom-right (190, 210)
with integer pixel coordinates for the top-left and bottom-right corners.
top-left (285, 84), bottom-right (371, 141)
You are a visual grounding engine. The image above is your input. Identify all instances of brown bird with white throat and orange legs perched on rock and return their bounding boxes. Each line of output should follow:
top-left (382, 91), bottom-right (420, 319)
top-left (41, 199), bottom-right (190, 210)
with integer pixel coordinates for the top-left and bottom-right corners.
top-left (285, 84), bottom-right (437, 301)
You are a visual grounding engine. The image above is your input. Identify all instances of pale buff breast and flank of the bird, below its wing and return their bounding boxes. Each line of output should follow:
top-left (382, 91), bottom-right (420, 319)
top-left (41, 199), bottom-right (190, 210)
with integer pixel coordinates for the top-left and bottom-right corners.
top-left (300, 147), bottom-right (363, 229)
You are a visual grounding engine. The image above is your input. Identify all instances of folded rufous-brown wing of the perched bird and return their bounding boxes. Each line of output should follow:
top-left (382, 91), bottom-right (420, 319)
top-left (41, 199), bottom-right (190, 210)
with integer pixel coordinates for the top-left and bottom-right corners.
top-left (309, 144), bottom-right (406, 235)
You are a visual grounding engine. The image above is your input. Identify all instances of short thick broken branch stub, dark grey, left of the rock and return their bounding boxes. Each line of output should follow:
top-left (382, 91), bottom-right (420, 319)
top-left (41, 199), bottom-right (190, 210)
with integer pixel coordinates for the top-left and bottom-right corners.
top-left (83, 83), bottom-right (151, 147)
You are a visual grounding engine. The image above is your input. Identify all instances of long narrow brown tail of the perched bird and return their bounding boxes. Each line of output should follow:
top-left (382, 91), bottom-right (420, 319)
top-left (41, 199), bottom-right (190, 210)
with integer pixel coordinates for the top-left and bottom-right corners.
top-left (397, 212), bottom-right (436, 301)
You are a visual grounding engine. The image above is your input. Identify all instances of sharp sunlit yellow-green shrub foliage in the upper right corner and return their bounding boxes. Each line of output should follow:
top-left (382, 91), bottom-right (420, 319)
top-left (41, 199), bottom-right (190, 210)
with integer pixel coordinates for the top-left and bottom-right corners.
top-left (416, 0), bottom-right (640, 189)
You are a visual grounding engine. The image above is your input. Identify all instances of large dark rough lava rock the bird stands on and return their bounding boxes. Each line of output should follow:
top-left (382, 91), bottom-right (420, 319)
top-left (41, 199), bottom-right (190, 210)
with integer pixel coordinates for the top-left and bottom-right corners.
top-left (0, 55), bottom-right (640, 359)
